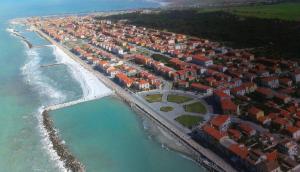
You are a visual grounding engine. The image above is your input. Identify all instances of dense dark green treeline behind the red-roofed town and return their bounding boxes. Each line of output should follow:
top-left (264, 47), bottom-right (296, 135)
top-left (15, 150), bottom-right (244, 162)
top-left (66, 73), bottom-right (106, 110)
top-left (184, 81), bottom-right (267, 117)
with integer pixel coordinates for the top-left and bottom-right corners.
top-left (99, 9), bottom-right (300, 58)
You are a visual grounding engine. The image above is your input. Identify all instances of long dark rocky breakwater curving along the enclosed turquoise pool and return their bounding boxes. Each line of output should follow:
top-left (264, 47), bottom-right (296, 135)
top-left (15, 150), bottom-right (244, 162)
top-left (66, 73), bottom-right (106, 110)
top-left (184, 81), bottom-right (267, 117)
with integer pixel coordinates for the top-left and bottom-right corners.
top-left (42, 110), bottom-right (85, 172)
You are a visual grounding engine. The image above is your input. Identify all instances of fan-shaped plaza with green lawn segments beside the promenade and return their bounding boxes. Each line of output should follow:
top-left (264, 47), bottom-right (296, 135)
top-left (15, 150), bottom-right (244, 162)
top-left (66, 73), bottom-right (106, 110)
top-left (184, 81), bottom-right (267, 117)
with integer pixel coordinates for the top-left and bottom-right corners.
top-left (138, 90), bottom-right (211, 132)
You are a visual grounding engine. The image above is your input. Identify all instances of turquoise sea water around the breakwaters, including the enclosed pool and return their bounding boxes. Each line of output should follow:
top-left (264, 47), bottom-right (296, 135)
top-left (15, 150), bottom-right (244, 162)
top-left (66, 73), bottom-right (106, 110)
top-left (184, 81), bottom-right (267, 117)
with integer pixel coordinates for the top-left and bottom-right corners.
top-left (0, 0), bottom-right (203, 172)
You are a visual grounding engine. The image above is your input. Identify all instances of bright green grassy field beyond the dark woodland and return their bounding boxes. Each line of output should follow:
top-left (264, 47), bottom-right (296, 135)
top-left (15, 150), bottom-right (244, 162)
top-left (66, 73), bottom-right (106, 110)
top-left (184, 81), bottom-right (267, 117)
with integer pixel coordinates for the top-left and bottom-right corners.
top-left (199, 2), bottom-right (300, 21)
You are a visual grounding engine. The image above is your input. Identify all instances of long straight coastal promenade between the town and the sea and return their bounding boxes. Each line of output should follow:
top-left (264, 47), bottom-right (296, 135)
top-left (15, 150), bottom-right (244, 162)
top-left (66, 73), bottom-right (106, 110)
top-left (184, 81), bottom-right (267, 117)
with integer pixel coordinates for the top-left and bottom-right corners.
top-left (34, 28), bottom-right (236, 172)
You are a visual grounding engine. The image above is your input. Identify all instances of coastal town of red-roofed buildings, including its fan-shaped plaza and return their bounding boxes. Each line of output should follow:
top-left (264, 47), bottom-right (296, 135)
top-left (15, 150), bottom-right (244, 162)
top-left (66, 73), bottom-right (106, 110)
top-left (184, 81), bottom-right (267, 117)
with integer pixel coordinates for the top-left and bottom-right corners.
top-left (27, 15), bottom-right (300, 172)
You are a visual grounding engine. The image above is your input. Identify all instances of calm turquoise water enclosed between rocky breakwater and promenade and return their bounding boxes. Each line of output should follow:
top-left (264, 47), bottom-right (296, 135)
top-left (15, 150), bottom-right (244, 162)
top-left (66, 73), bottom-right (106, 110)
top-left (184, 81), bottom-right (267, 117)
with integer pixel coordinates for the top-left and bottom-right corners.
top-left (50, 97), bottom-right (205, 172)
